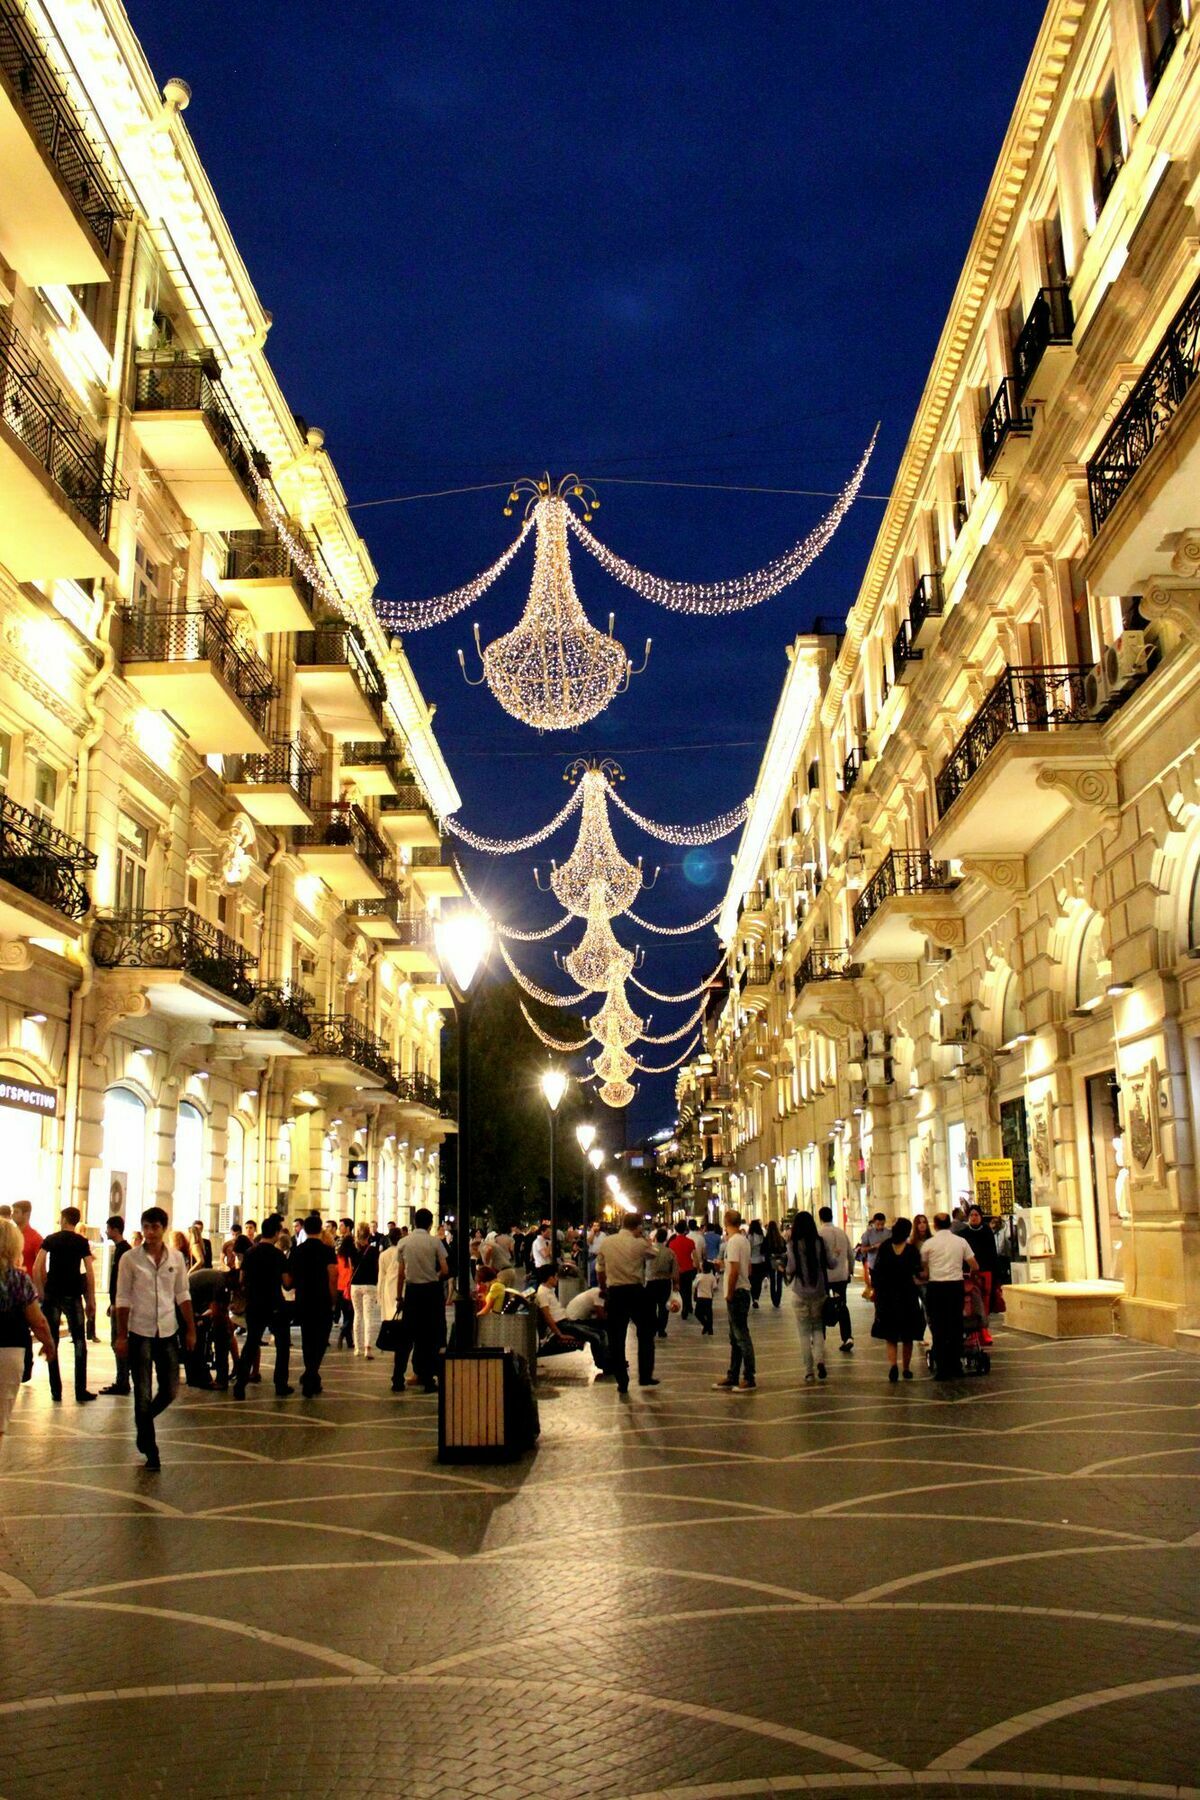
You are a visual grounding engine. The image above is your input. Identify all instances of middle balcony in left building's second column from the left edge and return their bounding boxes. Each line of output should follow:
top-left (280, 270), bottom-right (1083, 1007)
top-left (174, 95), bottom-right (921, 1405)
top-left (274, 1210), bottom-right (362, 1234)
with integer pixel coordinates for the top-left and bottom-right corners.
top-left (121, 599), bottom-right (277, 756)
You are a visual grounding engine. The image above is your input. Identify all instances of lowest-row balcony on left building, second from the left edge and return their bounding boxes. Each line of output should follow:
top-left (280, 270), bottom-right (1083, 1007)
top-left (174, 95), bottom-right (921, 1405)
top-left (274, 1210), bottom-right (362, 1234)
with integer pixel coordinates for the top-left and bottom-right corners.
top-left (92, 905), bottom-right (255, 1024)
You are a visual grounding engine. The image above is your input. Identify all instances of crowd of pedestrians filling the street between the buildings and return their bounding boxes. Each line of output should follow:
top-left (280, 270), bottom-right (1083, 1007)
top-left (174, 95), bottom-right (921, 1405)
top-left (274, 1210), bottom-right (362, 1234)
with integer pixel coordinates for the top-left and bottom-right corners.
top-left (0, 1201), bottom-right (1006, 1471)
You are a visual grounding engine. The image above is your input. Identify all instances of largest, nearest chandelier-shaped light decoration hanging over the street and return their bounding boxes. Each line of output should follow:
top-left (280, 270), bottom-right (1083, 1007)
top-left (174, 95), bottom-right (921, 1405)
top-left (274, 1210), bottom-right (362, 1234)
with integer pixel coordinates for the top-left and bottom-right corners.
top-left (459, 475), bottom-right (649, 731)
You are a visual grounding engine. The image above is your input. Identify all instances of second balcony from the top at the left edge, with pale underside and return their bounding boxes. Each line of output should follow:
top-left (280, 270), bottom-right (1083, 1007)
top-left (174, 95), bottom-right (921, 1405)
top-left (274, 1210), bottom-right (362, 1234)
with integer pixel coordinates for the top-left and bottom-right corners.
top-left (0, 315), bottom-right (130, 581)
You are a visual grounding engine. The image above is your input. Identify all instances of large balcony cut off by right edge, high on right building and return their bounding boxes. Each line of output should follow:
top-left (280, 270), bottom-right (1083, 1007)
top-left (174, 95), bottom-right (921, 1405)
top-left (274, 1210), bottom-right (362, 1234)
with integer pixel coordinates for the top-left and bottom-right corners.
top-left (1083, 270), bottom-right (1200, 594)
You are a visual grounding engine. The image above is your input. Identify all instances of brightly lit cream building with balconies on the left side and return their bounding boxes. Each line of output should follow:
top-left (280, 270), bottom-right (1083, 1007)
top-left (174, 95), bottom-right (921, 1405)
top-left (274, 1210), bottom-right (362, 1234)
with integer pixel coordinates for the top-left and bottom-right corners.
top-left (0, 0), bottom-right (459, 1240)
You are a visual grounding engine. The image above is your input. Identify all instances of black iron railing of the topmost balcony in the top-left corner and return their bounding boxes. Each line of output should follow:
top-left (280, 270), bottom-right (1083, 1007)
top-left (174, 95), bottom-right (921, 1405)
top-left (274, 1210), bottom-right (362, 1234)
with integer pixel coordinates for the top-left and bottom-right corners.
top-left (0, 0), bottom-right (130, 259)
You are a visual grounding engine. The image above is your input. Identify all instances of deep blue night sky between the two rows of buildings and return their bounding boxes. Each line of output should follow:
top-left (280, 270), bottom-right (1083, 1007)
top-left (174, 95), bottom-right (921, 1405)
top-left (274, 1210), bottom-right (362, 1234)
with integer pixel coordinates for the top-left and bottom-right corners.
top-left (130, 0), bottom-right (1042, 1132)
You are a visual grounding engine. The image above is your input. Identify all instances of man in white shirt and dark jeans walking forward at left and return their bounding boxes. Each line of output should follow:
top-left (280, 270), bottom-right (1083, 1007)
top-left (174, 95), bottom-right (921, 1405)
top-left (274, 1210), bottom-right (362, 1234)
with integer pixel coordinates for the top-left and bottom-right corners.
top-left (113, 1206), bottom-right (196, 1471)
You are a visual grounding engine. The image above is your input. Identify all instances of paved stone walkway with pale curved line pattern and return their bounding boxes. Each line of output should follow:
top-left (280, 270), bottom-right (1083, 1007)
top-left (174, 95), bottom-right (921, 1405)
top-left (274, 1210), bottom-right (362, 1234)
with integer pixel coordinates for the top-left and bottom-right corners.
top-left (0, 1301), bottom-right (1200, 1800)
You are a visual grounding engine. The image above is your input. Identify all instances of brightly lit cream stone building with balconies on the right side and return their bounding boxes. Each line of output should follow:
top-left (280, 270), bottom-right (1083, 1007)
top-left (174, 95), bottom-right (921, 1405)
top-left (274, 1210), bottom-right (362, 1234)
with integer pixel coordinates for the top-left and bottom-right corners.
top-left (698, 0), bottom-right (1200, 1346)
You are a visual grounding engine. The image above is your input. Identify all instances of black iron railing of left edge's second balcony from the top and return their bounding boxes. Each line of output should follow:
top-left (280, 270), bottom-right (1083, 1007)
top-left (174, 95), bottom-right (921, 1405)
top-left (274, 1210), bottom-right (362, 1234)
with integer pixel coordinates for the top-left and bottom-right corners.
top-left (0, 315), bottom-right (130, 538)
